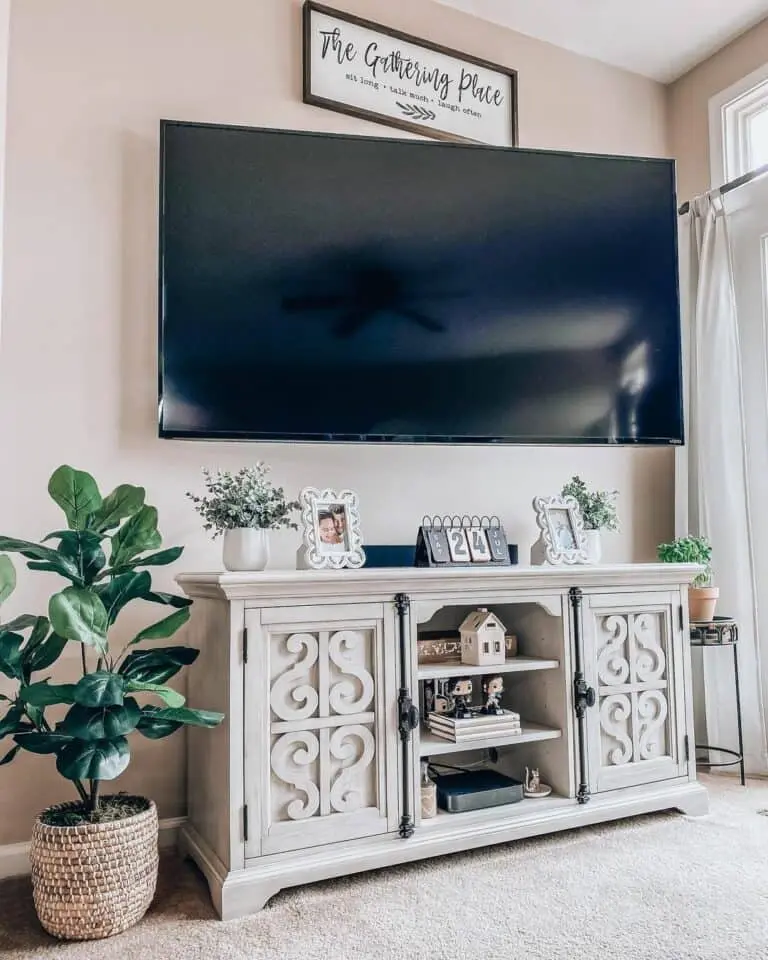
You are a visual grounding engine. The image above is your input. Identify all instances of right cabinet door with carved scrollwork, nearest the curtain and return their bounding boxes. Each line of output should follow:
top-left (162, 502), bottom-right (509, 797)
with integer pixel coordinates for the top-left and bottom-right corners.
top-left (583, 593), bottom-right (687, 793)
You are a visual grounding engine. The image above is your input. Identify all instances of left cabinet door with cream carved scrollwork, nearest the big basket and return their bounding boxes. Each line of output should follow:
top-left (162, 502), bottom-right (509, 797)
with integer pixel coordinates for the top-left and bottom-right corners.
top-left (245, 604), bottom-right (397, 857)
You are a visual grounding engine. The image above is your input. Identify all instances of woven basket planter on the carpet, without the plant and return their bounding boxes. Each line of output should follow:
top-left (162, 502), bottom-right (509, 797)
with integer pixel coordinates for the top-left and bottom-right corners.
top-left (30, 801), bottom-right (158, 940)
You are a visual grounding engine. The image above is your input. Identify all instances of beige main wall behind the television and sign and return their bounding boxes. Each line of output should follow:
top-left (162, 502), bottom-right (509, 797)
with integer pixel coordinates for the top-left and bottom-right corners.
top-left (0, 0), bottom-right (673, 844)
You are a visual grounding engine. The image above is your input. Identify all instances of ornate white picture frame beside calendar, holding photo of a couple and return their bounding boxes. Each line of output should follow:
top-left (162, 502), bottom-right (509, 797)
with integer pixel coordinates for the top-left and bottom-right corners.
top-left (298, 487), bottom-right (365, 570)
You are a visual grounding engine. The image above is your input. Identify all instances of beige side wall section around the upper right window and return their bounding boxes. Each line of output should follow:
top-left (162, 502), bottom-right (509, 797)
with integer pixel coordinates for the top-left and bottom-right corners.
top-left (667, 20), bottom-right (768, 202)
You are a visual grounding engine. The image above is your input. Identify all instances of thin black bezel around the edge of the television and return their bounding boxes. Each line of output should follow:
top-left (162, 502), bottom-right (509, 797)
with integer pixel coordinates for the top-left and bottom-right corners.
top-left (157, 119), bottom-right (685, 447)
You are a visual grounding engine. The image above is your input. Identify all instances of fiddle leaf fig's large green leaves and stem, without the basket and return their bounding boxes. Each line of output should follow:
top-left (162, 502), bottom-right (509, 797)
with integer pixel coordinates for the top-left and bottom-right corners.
top-left (0, 466), bottom-right (223, 817)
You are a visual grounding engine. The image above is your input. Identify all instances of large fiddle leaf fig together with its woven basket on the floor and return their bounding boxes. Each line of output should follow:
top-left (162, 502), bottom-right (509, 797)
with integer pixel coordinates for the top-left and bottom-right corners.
top-left (0, 466), bottom-right (223, 939)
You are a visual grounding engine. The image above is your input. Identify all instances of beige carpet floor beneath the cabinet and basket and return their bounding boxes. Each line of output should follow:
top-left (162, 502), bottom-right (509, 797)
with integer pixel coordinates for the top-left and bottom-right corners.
top-left (0, 778), bottom-right (768, 960)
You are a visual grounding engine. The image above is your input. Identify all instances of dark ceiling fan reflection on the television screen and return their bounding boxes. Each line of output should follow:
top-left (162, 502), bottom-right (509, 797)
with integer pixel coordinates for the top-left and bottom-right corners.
top-left (283, 259), bottom-right (461, 339)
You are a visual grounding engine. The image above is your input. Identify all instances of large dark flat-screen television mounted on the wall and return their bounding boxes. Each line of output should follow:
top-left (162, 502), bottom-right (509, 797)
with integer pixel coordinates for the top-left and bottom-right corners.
top-left (160, 121), bottom-right (683, 444)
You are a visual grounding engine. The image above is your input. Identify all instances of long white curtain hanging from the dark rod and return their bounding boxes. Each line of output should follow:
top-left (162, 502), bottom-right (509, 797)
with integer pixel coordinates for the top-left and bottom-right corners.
top-left (687, 192), bottom-right (768, 773)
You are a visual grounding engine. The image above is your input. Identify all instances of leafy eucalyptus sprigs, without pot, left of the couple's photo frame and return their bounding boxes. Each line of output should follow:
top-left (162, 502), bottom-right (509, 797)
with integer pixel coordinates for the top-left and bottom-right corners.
top-left (187, 463), bottom-right (299, 538)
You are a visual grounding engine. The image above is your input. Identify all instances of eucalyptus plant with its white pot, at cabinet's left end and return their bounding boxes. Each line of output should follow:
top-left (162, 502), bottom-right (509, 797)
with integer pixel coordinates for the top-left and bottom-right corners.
top-left (187, 463), bottom-right (299, 570)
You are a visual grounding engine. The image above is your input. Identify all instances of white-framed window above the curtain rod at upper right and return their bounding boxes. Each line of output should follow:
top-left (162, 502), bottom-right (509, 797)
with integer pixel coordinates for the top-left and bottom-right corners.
top-left (709, 66), bottom-right (768, 187)
